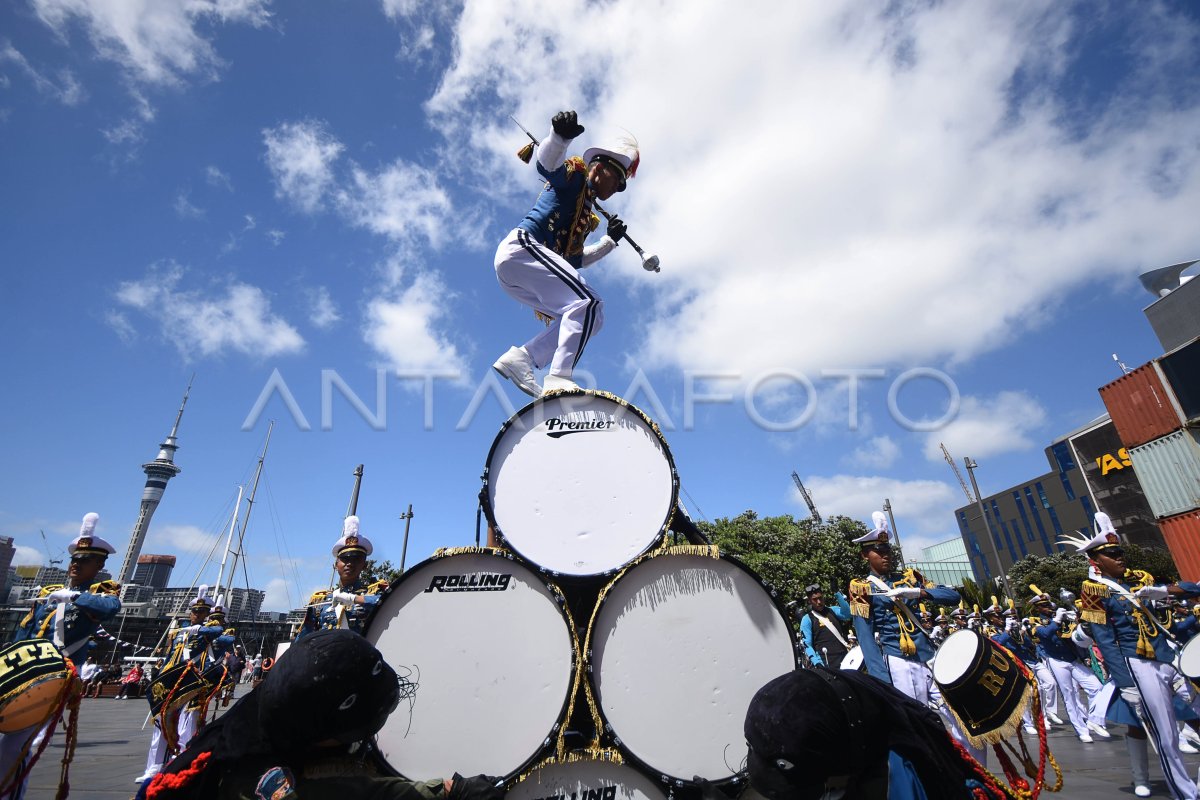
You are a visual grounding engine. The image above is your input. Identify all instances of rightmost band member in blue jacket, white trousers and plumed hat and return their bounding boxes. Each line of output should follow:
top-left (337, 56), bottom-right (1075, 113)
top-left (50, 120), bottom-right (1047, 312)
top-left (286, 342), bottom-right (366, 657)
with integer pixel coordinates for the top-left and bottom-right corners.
top-left (1064, 512), bottom-right (1200, 800)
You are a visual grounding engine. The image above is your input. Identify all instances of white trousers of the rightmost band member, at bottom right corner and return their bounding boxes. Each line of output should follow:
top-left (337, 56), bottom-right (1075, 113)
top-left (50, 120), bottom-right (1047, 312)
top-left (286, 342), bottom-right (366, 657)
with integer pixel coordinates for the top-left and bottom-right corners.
top-left (1121, 658), bottom-right (1198, 800)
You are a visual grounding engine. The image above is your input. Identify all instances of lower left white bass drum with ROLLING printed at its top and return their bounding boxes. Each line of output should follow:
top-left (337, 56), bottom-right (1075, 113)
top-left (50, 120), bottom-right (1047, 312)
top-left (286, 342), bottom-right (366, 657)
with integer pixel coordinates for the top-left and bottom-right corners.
top-left (364, 548), bottom-right (577, 781)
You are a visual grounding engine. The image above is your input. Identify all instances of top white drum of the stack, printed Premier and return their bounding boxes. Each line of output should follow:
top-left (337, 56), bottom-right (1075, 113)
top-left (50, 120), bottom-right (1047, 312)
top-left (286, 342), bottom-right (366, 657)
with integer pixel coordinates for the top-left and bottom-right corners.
top-left (484, 390), bottom-right (679, 576)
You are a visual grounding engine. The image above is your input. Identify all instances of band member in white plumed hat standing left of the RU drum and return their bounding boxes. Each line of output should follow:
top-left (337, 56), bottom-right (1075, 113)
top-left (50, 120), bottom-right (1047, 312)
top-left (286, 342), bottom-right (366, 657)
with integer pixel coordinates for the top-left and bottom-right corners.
top-left (850, 511), bottom-right (959, 704)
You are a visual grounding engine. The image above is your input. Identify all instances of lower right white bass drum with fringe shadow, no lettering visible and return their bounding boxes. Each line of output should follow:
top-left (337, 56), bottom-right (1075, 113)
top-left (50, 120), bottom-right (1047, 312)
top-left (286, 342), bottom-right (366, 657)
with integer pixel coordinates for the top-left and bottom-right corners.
top-left (588, 548), bottom-right (796, 783)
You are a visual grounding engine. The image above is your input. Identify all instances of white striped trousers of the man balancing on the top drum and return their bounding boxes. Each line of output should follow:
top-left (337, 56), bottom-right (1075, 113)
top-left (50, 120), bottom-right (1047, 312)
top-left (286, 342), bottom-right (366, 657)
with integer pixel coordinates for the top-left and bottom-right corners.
top-left (496, 228), bottom-right (604, 378)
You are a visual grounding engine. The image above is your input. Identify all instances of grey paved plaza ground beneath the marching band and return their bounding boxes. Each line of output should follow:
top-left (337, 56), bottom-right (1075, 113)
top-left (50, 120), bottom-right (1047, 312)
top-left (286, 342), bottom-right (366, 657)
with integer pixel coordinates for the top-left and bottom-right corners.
top-left (28, 687), bottom-right (1200, 800)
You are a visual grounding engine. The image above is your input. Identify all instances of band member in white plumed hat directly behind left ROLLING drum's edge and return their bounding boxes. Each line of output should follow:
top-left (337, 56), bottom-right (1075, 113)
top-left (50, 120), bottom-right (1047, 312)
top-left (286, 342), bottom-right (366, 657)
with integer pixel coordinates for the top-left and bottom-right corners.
top-left (296, 516), bottom-right (388, 639)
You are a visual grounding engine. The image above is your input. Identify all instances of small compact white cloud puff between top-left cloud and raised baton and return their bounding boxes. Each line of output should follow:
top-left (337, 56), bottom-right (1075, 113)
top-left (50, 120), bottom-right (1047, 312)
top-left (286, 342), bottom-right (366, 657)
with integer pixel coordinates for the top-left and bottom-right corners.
top-left (263, 120), bottom-right (344, 213)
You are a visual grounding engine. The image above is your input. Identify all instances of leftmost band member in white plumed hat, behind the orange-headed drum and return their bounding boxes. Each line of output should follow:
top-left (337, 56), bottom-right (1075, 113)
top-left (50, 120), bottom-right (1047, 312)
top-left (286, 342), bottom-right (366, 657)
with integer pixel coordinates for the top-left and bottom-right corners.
top-left (0, 512), bottom-right (121, 799)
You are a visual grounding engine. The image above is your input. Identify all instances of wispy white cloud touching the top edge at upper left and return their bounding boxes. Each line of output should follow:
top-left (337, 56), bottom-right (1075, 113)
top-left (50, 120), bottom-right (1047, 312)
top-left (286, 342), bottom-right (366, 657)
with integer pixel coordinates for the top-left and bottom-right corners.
top-left (34, 0), bottom-right (270, 85)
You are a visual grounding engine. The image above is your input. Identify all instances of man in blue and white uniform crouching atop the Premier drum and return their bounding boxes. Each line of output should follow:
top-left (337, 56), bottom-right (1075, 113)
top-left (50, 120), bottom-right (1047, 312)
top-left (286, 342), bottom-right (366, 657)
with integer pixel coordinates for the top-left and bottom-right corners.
top-left (492, 112), bottom-right (641, 397)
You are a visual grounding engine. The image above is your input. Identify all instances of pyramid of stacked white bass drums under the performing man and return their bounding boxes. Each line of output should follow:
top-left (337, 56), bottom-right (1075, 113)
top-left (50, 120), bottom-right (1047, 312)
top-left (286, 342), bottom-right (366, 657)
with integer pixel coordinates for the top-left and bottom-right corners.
top-left (366, 390), bottom-right (796, 800)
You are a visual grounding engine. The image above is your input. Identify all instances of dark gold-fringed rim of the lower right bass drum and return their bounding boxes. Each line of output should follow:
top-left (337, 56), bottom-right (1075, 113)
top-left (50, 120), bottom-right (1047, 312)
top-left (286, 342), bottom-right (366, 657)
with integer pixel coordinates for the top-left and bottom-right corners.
top-left (583, 545), bottom-right (802, 787)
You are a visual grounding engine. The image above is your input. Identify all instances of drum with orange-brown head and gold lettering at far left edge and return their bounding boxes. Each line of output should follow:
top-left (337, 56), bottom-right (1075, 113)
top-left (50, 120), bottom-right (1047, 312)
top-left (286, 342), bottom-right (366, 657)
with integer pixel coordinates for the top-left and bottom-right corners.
top-left (0, 639), bottom-right (72, 734)
